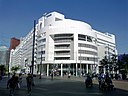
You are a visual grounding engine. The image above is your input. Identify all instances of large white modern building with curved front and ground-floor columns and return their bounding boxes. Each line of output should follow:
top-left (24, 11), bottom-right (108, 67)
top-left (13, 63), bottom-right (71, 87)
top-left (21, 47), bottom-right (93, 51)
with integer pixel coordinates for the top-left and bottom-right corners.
top-left (11, 12), bottom-right (117, 76)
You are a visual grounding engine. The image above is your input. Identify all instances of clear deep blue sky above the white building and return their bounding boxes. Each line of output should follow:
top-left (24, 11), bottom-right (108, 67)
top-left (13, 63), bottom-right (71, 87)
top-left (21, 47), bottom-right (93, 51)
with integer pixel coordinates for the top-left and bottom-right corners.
top-left (0, 0), bottom-right (128, 54)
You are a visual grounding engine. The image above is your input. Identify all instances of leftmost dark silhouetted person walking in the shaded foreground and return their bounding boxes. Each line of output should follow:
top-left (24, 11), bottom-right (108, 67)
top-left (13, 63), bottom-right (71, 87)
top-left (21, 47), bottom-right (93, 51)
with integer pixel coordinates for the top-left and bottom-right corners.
top-left (7, 74), bottom-right (17, 96)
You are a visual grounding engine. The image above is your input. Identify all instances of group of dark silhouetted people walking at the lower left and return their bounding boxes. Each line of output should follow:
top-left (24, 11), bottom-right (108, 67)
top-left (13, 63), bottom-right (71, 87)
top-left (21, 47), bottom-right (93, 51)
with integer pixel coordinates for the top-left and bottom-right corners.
top-left (7, 73), bottom-right (33, 96)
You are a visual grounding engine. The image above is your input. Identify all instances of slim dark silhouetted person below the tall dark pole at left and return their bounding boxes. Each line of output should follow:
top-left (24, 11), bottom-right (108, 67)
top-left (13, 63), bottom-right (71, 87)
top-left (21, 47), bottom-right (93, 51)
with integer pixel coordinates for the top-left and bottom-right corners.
top-left (26, 73), bottom-right (33, 95)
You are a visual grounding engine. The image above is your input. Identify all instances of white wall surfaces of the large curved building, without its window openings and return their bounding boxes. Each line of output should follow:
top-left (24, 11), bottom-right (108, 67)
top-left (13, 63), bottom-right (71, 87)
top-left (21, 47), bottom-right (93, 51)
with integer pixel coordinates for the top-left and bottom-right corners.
top-left (10, 12), bottom-right (116, 74)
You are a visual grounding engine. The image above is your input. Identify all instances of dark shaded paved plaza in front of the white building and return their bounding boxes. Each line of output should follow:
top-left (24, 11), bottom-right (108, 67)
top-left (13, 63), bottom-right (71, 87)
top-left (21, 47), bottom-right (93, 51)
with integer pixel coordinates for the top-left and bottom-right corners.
top-left (0, 77), bottom-right (128, 96)
